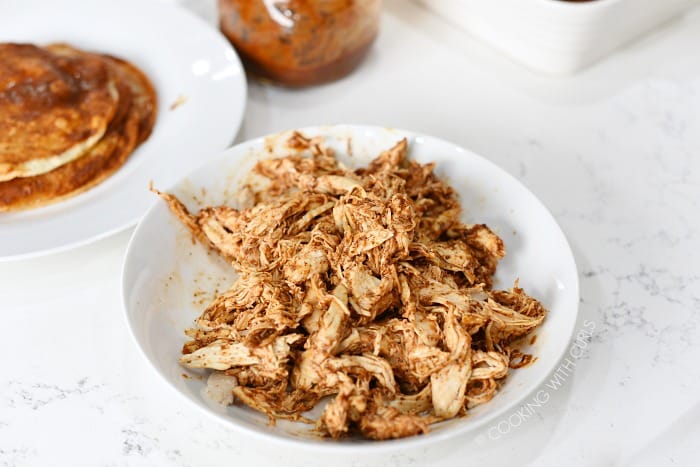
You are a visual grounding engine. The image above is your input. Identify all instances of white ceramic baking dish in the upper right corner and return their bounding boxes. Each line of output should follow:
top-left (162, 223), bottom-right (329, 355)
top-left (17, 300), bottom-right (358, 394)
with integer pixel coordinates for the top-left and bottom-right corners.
top-left (419, 0), bottom-right (700, 73)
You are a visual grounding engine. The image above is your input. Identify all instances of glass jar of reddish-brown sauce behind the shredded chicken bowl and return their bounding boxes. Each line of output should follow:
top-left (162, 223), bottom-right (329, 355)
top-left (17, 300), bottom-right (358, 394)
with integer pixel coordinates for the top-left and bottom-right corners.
top-left (219, 0), bottom-right (381, 86)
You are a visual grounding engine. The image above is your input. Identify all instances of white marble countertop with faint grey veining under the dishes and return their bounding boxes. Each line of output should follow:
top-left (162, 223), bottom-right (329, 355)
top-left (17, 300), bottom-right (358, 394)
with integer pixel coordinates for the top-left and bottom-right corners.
top-left (0, 0), bottom-right (700, 467)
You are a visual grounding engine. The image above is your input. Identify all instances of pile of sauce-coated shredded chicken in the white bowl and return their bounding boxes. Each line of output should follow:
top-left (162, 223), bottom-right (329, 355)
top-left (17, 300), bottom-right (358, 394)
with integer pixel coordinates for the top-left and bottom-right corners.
top-left (160, 133), bottom-right (546, 439)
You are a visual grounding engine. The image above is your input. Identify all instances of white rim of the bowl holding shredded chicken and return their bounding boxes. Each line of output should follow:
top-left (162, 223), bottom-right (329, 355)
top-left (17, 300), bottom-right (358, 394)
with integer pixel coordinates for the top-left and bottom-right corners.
top-left (120, 124), bottom-right (580, 454)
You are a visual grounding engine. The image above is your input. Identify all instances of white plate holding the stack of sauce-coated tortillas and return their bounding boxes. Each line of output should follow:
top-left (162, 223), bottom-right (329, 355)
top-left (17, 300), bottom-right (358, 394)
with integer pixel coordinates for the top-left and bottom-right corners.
top-left (0, 0), bottom-right (246, 260)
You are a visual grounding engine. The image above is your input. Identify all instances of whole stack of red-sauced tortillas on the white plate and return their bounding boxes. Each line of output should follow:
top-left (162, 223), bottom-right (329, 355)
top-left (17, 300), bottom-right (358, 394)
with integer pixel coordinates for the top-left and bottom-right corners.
top-left (0, 43), bottom-right (157, 211)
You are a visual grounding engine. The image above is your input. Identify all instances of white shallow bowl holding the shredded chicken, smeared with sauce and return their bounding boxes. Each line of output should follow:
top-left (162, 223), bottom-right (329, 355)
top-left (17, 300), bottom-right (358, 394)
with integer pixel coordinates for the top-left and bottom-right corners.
top-left (122, 126), bottom-right (578, 450)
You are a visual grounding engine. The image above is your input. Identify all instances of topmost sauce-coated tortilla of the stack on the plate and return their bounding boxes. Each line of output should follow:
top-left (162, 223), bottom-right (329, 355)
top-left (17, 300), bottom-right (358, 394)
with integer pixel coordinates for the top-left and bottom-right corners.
top-left (0, 44), bottom-right (118, 181)
